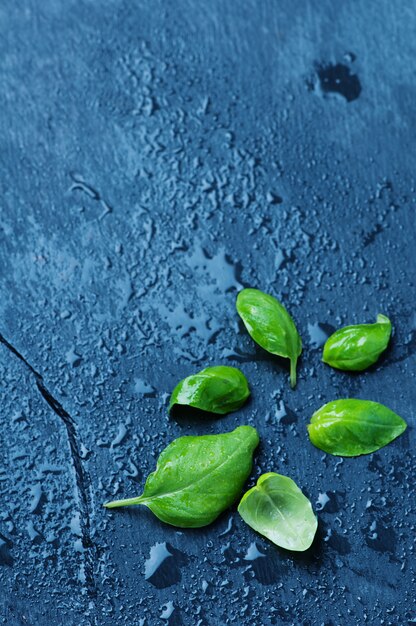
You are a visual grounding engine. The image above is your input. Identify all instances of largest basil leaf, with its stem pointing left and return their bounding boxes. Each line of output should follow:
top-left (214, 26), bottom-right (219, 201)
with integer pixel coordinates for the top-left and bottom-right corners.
top-left (104, 426), bottom-right (259, 528)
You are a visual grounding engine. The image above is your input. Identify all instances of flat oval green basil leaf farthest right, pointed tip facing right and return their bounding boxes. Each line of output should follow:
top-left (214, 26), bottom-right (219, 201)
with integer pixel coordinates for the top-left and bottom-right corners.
top-left (308, 398), bottom-right (407, 456)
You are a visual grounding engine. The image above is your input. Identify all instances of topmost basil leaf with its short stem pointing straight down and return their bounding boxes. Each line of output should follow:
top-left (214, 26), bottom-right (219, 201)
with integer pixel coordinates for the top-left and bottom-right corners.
top-left (237, 289), bottom-right (302, 388)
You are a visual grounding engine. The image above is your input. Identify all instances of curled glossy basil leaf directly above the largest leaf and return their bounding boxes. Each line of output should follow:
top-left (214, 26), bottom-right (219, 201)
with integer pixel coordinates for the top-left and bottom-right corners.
top-left (169, 365), bottom-right (250, 415)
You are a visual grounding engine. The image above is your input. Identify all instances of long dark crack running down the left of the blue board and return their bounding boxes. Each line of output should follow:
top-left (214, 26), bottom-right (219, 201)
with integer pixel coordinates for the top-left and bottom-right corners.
top-left (0, 333), bottom-right (96, 596)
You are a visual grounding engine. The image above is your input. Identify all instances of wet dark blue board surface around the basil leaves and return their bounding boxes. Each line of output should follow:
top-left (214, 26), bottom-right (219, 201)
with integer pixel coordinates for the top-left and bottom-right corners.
top-left (0, 0), bottom-right (416, 626)
